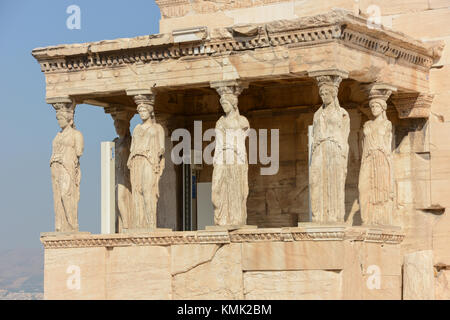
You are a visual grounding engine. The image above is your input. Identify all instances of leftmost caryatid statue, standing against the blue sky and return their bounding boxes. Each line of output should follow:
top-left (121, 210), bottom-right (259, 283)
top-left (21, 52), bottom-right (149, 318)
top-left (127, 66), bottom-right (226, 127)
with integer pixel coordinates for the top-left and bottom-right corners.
top-left (50, 100), bottom-right (84, 232)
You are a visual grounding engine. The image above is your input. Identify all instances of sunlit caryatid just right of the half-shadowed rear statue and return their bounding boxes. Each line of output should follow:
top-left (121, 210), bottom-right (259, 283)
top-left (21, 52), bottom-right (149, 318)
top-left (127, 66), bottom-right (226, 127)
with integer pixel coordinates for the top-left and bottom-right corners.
top-left (128, 94), bottom-right (165, 230)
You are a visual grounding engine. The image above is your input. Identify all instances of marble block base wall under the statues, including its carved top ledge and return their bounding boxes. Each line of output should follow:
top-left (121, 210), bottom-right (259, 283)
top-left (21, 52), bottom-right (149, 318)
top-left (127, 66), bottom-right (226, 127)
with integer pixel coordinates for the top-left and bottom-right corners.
top-left (41, 226), bottom-right (402, 299)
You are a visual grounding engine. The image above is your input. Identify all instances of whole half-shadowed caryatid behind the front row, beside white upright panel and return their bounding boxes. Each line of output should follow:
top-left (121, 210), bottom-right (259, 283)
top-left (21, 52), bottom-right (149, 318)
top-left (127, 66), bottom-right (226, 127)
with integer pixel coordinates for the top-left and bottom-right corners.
top-left (112, 112), bottom-right (133, 233)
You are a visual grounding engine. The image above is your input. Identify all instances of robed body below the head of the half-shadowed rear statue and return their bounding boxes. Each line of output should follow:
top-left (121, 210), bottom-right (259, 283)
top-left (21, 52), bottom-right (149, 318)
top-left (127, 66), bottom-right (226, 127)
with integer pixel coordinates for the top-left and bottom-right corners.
top-left (114, 134), bottom-right (133, 233)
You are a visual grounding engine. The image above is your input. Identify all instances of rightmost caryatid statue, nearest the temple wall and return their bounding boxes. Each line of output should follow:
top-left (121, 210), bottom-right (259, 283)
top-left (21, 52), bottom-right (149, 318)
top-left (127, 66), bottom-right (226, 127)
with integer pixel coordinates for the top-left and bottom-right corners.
top-left (358, 84), bottom-right (395, 225)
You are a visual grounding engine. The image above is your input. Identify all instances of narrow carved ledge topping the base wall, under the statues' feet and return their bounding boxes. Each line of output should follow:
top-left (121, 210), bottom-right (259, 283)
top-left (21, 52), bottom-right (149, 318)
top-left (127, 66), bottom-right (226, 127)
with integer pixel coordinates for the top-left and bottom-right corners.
top-left (41, 224), bottom-right (405, 249)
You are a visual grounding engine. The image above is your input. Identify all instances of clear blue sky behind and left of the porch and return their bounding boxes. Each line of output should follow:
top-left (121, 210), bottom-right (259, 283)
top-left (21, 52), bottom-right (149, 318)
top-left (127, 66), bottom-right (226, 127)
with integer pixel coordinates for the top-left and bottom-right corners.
top-left (0, 0), bottom-right (160, 250)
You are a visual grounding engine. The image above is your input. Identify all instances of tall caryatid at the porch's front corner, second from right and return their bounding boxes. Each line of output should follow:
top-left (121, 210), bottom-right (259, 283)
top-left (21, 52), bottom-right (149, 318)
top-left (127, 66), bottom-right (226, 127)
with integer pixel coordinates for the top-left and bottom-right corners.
top-left (309, 74), bottom-right (350, 223)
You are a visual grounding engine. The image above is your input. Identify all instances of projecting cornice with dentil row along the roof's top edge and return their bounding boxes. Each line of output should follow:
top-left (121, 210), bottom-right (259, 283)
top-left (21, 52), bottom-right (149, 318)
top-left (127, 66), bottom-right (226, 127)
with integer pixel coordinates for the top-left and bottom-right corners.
top-left (32, 10), bottom-right (436, 73)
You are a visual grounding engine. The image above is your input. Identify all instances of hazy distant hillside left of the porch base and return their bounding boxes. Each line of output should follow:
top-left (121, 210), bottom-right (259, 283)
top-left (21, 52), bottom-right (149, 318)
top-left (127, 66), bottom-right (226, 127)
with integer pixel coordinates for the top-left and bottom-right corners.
top-left (0, 249), bottom-right (44, 299)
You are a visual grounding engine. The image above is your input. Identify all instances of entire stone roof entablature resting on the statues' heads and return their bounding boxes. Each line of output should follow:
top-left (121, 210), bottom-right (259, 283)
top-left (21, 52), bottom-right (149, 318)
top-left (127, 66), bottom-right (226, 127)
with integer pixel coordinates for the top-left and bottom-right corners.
top-left (32, 10), bottom-right (443, 115)
